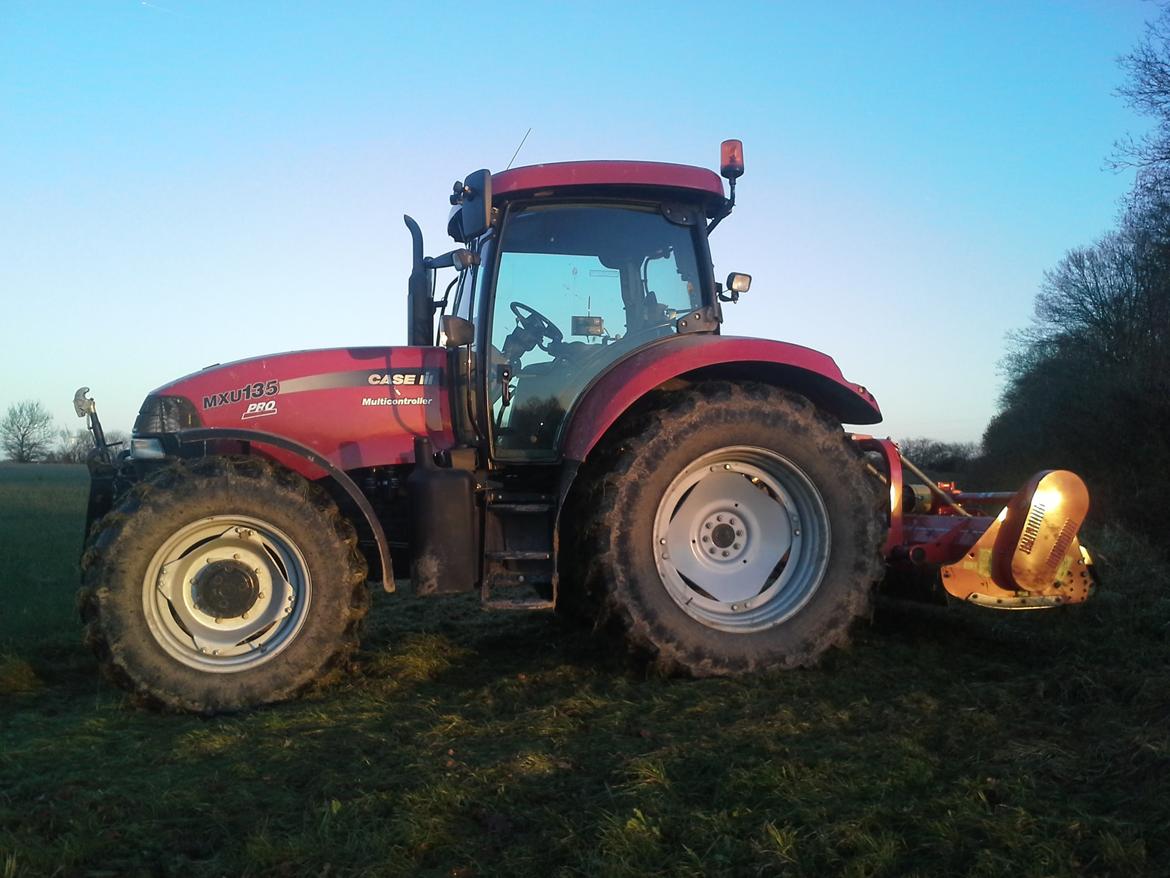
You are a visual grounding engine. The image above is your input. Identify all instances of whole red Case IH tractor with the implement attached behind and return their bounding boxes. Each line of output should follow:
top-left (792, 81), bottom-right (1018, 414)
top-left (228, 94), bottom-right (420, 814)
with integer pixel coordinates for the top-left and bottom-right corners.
top-left (75, 140), bottom-right (1093, 713)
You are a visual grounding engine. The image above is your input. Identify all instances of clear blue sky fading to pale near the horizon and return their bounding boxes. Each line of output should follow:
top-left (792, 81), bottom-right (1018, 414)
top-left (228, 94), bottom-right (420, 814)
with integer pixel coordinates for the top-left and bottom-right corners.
top-left (0, 0), bottom-right (1157, 440)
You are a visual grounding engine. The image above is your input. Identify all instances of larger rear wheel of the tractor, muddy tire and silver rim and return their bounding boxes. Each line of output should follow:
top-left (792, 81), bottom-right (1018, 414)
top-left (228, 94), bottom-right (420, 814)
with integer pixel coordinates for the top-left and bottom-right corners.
top-left (586, 383), bottom-right (885, 677)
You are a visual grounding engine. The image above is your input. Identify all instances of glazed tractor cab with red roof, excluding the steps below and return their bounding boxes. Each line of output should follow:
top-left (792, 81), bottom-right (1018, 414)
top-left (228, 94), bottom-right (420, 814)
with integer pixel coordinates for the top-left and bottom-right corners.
top-left (407, 149), bottom-right (746, 465)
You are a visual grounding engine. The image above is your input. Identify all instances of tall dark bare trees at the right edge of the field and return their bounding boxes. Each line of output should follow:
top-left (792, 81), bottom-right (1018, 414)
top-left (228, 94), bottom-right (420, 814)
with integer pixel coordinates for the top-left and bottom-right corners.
top-left (973, 8), bottom-right (1170, 547)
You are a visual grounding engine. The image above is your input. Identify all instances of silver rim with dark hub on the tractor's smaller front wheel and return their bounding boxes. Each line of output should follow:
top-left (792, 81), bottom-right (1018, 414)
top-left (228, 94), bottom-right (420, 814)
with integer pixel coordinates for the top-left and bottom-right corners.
top-left (143, 515), bottom-right (312, 673)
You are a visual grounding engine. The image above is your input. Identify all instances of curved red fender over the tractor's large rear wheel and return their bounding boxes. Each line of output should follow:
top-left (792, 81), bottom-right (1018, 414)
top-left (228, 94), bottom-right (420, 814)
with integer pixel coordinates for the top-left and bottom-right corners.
top-left (563, 334), bottom-right (881, 461)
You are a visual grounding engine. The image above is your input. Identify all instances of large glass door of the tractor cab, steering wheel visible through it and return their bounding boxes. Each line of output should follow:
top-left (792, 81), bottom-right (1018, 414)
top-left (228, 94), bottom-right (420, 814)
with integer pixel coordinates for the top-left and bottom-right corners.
top-left (486, 201), bottom-right (703, 461)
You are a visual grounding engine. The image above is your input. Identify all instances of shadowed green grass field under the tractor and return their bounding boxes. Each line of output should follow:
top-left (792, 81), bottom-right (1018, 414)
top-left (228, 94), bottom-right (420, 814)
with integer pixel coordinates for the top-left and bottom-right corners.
top-left (0, 467), bottom-right (1170, 878)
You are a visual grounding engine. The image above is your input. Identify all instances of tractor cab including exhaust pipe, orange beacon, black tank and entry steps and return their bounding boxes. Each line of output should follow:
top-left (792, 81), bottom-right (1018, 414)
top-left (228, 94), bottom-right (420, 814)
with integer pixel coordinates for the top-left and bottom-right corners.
top-left (397, 148), bottom-right (746, 606)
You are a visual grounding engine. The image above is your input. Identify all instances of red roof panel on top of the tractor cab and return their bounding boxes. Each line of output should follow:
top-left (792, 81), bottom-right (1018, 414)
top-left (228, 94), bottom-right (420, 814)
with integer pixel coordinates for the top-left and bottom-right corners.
top-left (491, 162), bottom-right (723, 198)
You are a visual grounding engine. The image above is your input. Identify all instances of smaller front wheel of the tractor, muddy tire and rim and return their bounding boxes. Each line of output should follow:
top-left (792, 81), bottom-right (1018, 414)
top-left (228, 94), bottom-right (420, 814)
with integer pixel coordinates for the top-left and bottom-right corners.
top-left (81, 457), bottom-right (370, 714)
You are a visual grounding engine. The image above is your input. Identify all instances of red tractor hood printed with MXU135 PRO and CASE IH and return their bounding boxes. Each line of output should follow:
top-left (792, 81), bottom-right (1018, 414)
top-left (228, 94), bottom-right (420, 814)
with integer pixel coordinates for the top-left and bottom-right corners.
top-left (135, 347), bottom-right (453, 471)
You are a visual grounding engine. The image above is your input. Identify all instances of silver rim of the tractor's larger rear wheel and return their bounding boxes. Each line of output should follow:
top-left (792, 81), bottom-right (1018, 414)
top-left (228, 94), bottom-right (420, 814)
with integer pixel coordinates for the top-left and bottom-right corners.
top-left (654, 446), bottom-right (831, 633)
